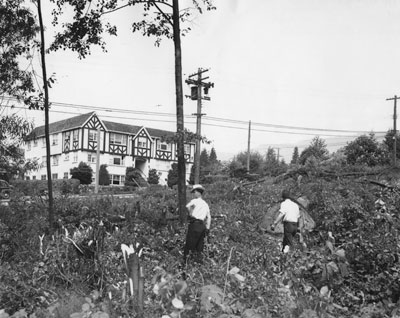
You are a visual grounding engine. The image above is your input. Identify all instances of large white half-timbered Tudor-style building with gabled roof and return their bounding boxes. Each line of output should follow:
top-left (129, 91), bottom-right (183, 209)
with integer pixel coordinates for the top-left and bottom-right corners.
top-left (24, 112), bottom-right (195, 185)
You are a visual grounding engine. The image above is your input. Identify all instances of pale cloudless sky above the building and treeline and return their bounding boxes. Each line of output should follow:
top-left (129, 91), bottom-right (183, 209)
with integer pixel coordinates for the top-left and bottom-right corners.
top-left (4, 0), bottom-right (400, 161)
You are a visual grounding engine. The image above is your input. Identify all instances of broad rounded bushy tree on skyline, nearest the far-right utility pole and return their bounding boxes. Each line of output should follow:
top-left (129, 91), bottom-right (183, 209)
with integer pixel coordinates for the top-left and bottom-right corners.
top-left (344, 133), bottom-right (389, 166)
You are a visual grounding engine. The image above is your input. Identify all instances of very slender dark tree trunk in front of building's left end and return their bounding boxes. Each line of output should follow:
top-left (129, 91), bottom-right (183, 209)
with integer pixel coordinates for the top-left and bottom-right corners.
top-left (37, 0), bottom-right (54, 233)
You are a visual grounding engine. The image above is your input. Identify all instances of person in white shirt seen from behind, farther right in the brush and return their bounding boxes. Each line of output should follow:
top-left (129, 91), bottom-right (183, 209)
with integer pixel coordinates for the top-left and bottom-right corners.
top-left (271, 190), bottom-right (300, 253)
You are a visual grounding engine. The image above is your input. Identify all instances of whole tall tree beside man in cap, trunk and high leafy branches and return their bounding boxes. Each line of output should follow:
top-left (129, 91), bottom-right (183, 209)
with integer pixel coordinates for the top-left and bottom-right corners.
top-left (52, 0), bottom-right (215, 223)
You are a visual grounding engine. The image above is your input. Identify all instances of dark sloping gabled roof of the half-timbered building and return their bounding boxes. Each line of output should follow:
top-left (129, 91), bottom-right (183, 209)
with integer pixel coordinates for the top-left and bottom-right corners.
top-left (26, 112), bottom-right (175, 140)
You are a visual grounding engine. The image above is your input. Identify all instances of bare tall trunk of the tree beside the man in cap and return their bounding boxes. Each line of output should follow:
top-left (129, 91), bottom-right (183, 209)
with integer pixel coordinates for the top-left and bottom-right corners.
top-left (172, 0), bottom-right (186, 224)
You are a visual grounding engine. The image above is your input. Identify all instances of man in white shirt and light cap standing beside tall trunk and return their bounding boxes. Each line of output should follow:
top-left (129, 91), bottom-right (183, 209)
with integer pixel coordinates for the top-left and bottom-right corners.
top-left (183, 184), bottom-right (211, 264)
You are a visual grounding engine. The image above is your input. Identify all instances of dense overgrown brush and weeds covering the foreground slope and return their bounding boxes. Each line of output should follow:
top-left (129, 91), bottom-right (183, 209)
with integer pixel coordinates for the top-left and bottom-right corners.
top-left (0, 163), bottom-right (400, 318)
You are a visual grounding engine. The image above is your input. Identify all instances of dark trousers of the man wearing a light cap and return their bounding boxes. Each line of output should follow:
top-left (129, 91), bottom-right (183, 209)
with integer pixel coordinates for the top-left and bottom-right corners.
top-left (183, 220), bottom-right (206, 263)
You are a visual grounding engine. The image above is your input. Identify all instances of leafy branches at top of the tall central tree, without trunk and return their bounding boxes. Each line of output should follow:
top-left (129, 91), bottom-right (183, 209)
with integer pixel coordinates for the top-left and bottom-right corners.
top-left (51, 0), bottom-right (215, 58)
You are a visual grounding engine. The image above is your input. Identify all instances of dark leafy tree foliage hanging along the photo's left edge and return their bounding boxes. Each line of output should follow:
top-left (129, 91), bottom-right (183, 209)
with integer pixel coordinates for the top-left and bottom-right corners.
top-left (0, 0), bottom-right (39, 176)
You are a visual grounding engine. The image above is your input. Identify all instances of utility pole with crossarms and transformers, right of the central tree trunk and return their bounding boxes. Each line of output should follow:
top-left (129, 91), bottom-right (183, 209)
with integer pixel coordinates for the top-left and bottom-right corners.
top-left (185, 68), bottom-right (214, 184)
